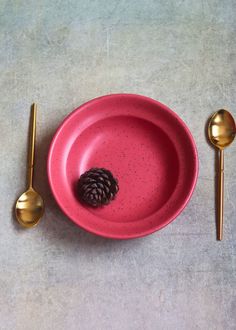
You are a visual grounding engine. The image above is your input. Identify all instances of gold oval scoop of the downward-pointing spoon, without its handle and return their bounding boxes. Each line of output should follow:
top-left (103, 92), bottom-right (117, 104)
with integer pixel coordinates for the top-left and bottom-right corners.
top-left (15, 188), bottom-right (44, 228)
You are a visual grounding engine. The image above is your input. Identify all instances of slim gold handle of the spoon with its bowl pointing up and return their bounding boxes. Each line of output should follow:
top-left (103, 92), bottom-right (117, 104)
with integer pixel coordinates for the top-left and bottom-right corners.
top-left (217, 149), bottom-right (224, 241)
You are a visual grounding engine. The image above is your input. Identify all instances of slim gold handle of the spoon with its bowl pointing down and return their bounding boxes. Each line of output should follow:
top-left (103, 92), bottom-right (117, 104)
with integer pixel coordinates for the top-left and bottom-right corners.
top-left (28, 103), bottom-right (37, 188)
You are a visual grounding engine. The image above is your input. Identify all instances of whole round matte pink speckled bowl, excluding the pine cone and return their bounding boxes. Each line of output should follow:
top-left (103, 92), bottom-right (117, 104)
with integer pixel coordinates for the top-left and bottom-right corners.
top-left (48, 94), bottom-right (198, 239)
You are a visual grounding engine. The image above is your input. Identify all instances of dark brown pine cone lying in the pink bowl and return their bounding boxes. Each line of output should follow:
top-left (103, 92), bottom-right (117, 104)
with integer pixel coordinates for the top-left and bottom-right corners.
top-left (78, 168), bottom-right (119, 207)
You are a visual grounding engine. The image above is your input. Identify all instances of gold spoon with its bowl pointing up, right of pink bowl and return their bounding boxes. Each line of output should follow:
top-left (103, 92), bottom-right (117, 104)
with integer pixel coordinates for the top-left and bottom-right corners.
top-left (208, 109), bottom-right (236, 241)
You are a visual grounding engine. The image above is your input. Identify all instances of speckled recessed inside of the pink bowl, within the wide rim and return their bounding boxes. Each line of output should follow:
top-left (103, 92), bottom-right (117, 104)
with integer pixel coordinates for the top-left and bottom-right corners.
top-left (66, 116), bottom-right (179, 222)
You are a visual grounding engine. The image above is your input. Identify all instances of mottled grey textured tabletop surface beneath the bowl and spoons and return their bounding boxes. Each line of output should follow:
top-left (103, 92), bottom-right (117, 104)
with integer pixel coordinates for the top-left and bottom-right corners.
top-left (0, 0), bottom-right (236, 330)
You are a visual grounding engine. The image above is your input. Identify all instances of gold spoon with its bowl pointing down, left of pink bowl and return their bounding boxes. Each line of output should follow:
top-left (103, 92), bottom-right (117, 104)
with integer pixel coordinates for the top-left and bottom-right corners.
top-left (15, 103), bottom-right (44, 228)
